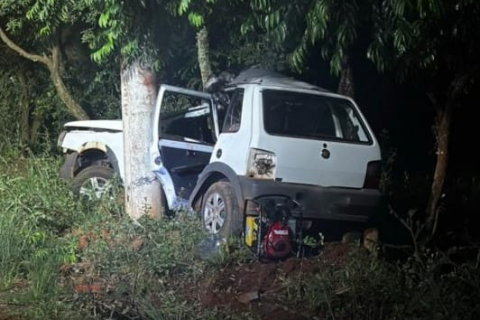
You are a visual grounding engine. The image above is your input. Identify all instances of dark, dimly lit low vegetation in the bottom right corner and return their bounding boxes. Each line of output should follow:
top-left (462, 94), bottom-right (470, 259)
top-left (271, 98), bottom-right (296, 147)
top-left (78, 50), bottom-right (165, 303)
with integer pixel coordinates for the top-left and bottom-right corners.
top-left (282, 247), bottom-right (480, 319)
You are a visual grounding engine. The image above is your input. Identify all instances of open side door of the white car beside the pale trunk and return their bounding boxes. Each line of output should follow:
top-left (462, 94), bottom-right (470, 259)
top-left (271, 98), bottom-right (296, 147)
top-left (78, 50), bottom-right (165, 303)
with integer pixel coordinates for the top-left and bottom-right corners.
top-left (153, 85), bottom-right (219, 210)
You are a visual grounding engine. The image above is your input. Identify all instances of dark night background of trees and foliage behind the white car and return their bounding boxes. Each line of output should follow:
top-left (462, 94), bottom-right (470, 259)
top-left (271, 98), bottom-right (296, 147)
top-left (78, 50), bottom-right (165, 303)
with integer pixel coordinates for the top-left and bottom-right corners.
top-left (0, 0), bottom-right (480, 239)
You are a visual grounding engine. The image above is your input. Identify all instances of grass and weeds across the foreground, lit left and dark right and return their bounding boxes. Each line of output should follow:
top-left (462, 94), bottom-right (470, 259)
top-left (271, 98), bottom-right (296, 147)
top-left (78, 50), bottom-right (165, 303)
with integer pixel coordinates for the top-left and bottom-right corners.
top-left (0, 157), bottom-right (480, 319)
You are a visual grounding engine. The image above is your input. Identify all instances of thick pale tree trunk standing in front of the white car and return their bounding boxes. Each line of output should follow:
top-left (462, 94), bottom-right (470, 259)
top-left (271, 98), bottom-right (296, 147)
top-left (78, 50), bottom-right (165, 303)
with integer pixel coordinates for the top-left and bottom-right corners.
top-left (121, 61), bottom-right (161, 220)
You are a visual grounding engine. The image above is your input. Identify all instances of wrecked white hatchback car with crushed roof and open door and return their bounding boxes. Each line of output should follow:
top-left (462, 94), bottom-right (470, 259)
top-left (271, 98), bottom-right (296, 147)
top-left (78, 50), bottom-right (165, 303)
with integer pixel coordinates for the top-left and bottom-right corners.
top-left (59, 69), bottom-right (381, 240)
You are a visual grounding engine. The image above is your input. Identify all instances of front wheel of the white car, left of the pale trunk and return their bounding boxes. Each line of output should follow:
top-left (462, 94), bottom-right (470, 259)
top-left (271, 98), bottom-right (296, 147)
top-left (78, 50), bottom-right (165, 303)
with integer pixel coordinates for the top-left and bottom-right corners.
top-left (72, 165), bottom-right (115, 200)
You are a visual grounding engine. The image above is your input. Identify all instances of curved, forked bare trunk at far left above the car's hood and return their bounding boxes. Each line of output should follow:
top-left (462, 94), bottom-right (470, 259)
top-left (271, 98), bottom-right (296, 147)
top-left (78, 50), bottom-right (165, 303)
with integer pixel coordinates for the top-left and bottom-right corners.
top-left (0, 28), bottom-right (89, 120)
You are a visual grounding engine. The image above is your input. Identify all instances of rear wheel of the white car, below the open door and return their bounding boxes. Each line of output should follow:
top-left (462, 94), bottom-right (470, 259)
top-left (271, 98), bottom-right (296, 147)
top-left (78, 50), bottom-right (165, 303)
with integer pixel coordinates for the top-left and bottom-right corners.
top-left (201, 181), bottom-right (243, 237)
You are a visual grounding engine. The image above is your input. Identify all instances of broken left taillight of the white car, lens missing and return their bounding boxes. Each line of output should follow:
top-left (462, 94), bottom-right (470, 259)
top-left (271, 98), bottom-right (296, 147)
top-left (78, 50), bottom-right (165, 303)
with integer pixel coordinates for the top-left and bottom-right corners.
top-left (248, 148), bottom-right (277, 180)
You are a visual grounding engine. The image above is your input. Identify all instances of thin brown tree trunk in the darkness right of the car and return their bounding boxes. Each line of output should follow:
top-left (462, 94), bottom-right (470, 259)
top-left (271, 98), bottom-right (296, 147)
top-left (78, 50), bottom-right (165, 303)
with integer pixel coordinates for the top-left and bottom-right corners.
top-left (426, 101), bottom-right (453, 236)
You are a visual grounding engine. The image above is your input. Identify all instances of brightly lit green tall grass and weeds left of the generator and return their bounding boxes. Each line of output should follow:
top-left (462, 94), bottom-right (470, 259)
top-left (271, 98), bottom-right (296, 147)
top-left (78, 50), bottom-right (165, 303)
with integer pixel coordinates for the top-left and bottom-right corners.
top-left (0, 154), bottom-right (223, 319)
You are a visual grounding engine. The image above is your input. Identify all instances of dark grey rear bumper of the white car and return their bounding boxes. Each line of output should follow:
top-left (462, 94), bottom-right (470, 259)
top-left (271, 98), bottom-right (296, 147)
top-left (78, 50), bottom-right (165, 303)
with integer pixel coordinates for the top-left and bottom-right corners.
top-left (239, 177), bottom-right (382, 223)
